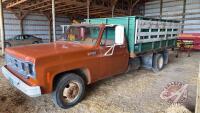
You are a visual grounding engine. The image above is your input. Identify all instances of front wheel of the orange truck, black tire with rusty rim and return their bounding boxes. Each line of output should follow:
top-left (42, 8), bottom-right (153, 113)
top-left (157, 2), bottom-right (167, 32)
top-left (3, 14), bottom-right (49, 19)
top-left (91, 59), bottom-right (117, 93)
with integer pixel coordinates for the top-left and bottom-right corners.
top-left (52, 73), bottom-right (85, 109)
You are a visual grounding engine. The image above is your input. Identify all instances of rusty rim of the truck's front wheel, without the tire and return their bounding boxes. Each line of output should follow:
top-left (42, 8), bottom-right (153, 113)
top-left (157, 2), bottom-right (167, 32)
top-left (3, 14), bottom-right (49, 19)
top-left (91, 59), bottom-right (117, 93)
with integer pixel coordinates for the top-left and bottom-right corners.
top-left (63, 81), bottom-right (80, 103)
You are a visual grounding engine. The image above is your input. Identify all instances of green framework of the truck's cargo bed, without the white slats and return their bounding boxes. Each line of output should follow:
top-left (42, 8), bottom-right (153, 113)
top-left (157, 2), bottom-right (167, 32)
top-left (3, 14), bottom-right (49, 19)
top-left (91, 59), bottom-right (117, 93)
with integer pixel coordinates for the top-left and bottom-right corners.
top-left (86, 16), bottom-right (179, 54)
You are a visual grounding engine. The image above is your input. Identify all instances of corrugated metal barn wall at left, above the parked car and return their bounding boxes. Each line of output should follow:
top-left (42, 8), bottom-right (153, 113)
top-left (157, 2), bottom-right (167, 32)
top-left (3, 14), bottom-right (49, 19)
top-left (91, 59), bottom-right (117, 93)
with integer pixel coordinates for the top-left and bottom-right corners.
top-left (1, 11), bottom-right (69, 40)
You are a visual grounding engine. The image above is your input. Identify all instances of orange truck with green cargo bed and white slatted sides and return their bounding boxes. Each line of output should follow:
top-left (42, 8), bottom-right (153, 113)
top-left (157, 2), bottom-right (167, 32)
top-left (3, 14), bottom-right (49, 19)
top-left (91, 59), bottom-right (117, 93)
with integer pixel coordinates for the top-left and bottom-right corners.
top-left (2, 16), bottom-right (180, 109)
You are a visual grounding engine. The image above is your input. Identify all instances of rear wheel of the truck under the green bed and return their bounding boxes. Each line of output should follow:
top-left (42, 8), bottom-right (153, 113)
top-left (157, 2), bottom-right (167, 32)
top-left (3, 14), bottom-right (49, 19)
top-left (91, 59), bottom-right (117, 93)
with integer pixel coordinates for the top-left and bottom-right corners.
top-left (153, 54), bottom-right (164, 72)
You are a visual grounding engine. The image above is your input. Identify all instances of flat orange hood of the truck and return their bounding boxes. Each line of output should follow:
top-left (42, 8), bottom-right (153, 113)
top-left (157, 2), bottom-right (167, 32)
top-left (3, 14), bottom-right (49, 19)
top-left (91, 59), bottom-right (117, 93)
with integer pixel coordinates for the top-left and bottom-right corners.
top-left (6, 41), bottom-right (91, 61)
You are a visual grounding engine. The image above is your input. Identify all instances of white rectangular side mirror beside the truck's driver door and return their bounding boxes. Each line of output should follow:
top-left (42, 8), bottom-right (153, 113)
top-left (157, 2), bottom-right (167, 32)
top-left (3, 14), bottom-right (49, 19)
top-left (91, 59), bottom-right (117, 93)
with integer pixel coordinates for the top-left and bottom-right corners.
top-left (115, 26), bottom-right (124, 45)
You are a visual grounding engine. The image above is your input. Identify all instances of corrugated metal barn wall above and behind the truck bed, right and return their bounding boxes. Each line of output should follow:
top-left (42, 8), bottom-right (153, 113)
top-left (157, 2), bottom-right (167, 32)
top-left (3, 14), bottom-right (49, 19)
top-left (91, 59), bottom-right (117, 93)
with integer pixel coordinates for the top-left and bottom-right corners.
top-left (145, 0), bottom-right (200, 33)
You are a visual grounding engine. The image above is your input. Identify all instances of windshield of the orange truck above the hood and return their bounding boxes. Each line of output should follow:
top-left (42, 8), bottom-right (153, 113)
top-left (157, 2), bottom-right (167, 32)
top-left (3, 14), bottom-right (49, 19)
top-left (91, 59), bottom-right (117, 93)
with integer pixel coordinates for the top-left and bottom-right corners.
top-left (64, 26), bottom-right (100, 45)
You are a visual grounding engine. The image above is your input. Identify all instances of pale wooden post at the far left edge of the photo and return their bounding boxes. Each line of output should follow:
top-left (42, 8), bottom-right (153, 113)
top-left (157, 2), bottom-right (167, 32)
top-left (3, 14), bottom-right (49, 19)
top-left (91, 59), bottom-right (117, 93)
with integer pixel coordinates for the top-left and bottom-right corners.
top-left (0, 0), bottom-right (5, 55)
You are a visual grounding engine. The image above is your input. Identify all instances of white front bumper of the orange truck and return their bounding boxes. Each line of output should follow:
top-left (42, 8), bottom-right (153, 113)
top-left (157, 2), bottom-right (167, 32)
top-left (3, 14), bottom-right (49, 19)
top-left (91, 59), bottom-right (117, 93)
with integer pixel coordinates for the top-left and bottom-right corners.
top-left (1, 66), bottom-right (41, 97)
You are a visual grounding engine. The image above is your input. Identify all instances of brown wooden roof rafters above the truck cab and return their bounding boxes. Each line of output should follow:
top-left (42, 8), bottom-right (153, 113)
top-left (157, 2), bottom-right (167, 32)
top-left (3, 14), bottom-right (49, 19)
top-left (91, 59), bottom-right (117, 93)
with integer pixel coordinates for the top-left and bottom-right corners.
top-left (5, 0), bottom-right (140, 17)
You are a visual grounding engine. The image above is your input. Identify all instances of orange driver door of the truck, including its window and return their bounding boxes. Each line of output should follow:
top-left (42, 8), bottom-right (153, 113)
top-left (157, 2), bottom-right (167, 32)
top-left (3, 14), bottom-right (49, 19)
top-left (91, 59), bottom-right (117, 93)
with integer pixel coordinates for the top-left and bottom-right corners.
top-left (100, 27), bottom-right (129, 78)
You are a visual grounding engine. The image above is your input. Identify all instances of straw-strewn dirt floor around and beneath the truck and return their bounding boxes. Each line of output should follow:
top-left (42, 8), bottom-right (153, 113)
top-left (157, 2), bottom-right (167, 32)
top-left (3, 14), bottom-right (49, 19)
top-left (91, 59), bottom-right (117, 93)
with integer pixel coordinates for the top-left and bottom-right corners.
top-left (0, 52), bottom-right (200, 113)
